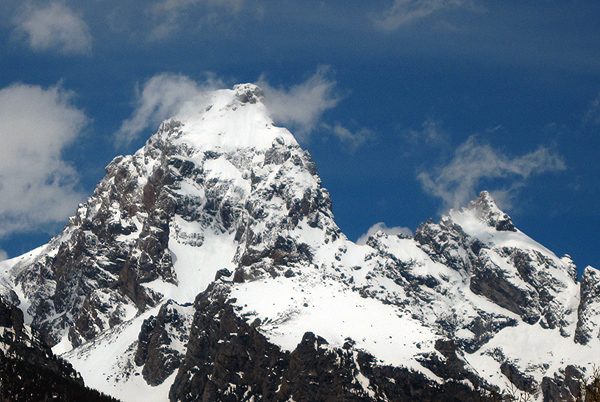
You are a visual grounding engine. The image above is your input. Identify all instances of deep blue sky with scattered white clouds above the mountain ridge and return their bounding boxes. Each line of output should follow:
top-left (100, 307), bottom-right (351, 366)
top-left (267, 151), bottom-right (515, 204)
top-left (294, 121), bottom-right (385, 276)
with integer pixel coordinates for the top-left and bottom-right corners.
top-left (0, 0), bottom-right (600, 269)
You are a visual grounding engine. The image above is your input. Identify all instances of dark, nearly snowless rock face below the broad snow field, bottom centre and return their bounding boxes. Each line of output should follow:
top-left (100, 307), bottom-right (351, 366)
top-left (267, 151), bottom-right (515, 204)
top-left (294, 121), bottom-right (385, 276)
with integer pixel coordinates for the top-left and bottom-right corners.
top-left (169, 286), bottom-right (491, 402)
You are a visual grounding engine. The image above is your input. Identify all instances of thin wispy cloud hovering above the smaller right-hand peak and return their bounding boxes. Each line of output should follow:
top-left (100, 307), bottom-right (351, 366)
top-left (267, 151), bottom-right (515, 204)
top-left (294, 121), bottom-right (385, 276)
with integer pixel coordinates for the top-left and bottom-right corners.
top-left (417, 136), bottom-right (566, 208)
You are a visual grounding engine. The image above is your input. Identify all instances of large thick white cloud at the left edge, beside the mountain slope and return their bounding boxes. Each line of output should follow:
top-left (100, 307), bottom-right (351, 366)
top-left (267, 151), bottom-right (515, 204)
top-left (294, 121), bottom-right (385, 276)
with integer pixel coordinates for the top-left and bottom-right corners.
top-left (0, 84), bottom-right (88, 236)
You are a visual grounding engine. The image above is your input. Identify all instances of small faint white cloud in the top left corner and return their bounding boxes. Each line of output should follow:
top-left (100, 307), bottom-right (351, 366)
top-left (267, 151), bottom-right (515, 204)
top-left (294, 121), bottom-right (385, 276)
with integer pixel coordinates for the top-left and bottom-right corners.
top-left (14, 2), bottom-right (92, 54)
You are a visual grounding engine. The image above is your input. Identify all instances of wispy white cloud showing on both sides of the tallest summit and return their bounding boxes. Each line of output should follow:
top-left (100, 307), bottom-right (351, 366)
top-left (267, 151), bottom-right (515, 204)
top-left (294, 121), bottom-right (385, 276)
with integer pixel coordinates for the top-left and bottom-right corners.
top-left (115, 67), bottom-right (350, 149)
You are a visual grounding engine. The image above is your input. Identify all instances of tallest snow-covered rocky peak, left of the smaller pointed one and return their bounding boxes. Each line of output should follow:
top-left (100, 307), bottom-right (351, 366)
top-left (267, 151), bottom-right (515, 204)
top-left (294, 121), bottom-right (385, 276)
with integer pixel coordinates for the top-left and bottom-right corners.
top-left (0, 84), bottom-right (340, 349)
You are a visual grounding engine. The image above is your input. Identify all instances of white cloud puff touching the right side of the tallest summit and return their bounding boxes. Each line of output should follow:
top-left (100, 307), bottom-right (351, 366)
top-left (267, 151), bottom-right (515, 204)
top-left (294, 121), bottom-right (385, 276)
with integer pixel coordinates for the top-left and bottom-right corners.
top-left (257, 67), bottom-right (343, 141)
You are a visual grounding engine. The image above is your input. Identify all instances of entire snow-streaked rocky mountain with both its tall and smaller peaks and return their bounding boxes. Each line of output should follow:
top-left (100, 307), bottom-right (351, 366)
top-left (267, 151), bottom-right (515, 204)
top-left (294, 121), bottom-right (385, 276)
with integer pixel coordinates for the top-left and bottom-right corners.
top-left (0, 84), bottom-right (600, 402)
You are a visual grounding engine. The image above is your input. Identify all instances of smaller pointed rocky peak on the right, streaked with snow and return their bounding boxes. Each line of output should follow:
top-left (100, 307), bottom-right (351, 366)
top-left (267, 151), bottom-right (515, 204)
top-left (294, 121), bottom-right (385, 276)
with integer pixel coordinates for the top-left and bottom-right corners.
top-left (415, 192), bottom-right (577, 337)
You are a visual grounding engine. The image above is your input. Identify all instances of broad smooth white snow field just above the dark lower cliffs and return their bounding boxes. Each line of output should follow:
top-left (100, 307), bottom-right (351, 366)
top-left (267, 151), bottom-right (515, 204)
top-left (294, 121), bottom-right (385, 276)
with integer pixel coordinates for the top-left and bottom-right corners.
top-left (231, 271), bottom-right (436, 376)
